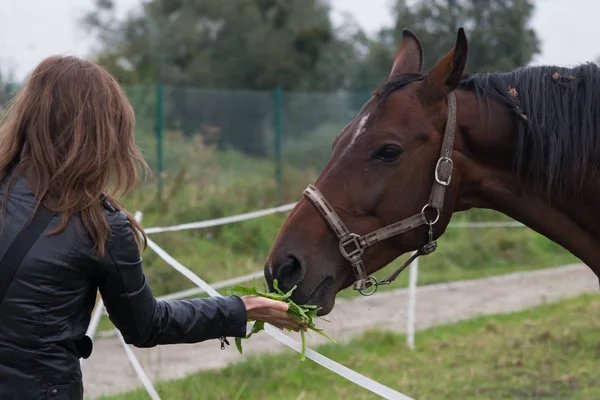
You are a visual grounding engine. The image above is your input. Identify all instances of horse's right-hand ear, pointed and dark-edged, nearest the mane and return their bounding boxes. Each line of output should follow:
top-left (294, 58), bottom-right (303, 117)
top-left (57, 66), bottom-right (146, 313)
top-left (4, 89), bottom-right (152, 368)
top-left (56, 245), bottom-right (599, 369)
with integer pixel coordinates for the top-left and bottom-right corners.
top-left (419, 28), bottom-right (469, 102)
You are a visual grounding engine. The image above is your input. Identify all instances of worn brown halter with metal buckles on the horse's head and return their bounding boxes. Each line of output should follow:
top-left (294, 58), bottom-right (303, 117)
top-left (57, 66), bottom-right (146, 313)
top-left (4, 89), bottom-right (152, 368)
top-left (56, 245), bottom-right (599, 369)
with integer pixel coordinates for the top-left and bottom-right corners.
top-left (304, 92), bottom-right (456, 296)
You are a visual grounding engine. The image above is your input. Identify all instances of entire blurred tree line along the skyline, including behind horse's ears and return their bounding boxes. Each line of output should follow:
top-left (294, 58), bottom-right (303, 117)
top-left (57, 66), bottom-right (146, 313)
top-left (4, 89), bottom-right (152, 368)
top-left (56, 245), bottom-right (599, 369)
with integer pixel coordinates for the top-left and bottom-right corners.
top-left (83, 0), bottom-right (540, 91)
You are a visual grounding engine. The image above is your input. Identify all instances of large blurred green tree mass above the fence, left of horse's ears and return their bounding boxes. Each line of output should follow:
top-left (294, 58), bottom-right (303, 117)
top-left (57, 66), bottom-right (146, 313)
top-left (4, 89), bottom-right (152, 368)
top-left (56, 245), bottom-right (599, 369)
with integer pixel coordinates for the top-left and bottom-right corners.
top-left (82, 0), bottom-right (354, 90)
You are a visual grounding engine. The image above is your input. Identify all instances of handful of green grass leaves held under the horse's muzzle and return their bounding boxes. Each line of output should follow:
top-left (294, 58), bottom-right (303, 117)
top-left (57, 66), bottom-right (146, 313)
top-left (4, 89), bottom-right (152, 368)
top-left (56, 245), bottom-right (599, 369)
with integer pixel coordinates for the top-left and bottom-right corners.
top-left (228, 280), bottom-right (337, 361)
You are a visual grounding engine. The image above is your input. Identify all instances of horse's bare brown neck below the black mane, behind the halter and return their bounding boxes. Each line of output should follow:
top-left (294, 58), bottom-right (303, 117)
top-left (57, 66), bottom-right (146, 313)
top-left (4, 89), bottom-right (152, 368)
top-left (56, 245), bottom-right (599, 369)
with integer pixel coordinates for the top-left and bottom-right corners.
top-left (455, 90), bottom-right (600, 276)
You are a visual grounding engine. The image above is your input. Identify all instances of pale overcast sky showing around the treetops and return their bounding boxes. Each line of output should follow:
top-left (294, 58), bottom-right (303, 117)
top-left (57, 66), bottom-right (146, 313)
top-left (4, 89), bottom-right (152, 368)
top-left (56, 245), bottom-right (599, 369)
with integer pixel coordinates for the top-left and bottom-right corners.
top-left (0, 0), bottom-right (600, 79)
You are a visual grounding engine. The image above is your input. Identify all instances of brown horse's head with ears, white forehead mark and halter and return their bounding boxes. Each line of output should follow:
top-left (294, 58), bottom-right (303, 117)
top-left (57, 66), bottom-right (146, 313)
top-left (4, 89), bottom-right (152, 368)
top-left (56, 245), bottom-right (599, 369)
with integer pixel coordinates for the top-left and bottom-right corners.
top-left (265, 28), bottom-right (467, 315)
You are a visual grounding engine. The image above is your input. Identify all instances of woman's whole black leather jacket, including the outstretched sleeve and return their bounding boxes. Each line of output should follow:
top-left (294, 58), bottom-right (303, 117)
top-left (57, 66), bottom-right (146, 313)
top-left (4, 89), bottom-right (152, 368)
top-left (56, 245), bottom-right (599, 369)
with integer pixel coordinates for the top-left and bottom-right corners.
top-left (0, 179), bottom-right (247, 400)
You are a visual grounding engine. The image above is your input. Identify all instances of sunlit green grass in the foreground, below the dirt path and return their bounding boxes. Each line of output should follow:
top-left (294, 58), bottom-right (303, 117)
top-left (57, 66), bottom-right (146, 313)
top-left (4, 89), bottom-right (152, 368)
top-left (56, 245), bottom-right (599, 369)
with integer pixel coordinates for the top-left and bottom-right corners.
top-left (98, 295), bottom-right (600, 400)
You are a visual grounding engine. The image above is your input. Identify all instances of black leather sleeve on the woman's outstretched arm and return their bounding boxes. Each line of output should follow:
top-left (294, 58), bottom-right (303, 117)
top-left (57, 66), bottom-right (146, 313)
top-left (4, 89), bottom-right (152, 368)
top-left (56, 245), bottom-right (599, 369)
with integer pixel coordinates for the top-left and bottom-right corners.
top-left (98, 211), bottom-right (247, 347)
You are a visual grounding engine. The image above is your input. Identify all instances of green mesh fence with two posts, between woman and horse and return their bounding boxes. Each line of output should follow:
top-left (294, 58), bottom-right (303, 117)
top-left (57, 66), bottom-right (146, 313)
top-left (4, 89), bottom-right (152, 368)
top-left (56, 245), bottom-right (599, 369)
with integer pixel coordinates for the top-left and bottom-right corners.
top-left (125, 86), bottom-right (368, 203)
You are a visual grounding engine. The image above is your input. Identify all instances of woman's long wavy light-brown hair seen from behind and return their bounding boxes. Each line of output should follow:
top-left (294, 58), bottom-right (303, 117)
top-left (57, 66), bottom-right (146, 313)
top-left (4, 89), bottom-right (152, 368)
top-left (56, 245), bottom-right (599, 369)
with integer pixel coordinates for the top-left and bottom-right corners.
top-left (0, 56), bottom-right (149, 257)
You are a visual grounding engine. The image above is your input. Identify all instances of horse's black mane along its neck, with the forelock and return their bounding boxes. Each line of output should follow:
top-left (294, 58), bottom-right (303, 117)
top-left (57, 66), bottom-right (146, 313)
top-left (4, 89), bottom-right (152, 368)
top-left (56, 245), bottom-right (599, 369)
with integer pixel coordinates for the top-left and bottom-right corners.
top-left (377, 63), bottom-right (600, 198)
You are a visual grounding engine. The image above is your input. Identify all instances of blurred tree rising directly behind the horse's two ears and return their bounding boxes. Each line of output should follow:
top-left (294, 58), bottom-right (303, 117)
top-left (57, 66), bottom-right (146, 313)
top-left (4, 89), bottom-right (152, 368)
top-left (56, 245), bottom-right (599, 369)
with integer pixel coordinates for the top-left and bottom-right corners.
top-left (354, 0), bottom-right (540, 89)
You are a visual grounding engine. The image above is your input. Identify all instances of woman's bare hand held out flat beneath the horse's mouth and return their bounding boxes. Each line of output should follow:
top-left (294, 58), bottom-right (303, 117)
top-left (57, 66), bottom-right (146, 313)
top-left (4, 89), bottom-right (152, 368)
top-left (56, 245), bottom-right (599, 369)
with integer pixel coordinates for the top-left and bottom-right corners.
top-left (242, 296), bottom-right (306, 332)
